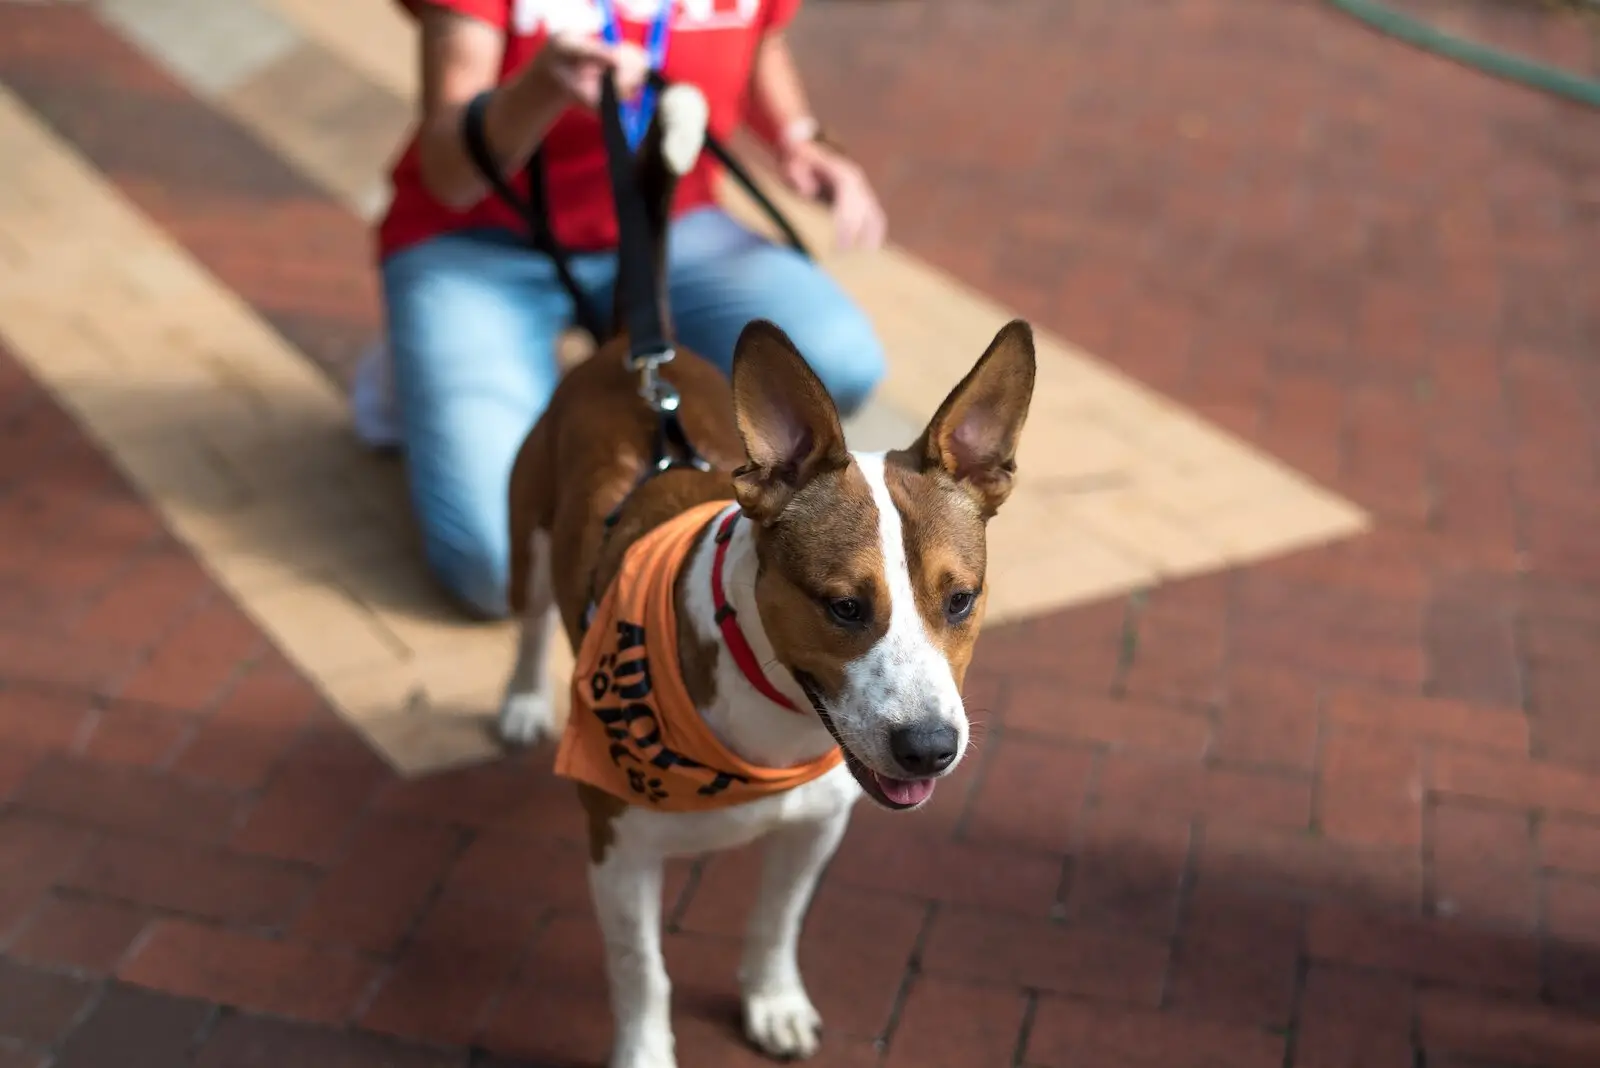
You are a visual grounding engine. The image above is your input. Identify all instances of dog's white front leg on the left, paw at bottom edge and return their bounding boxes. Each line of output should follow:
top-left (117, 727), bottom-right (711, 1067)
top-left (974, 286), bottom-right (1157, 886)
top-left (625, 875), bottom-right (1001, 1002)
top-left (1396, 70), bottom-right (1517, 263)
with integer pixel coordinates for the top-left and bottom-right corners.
top-left (589, 847), bottom-right (677, 1068)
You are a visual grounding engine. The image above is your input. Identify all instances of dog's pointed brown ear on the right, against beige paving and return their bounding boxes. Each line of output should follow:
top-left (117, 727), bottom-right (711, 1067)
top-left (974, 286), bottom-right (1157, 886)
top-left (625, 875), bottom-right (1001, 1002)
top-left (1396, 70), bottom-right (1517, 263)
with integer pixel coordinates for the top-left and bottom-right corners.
top-left (910, 320), bottom-right (1035, 520)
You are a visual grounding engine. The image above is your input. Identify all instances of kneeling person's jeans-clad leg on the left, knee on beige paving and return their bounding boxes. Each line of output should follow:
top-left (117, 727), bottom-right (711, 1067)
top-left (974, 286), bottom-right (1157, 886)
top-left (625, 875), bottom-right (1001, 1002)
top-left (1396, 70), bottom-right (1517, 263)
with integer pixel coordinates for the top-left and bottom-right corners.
top-left (382, 232), bottom-right (571, 617)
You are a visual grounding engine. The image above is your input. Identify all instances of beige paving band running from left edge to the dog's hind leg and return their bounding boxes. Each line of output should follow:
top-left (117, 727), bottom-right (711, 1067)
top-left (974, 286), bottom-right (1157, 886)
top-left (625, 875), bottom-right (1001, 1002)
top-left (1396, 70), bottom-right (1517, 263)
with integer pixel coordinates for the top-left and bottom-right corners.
top-left (0, 88), bottom-right (524, 772)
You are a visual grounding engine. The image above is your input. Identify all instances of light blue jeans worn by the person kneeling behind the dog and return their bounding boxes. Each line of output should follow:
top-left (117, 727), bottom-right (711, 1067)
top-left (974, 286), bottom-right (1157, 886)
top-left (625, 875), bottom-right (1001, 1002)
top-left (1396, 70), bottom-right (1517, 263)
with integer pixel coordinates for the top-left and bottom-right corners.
top-left (382, 208), bottom-right (883, 617)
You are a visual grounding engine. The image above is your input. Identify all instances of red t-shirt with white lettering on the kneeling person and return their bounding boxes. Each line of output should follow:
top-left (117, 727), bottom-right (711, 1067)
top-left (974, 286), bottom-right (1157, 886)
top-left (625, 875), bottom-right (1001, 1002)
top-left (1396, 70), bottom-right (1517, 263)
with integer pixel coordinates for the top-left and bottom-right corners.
top-left (378, 0), bottom-right (800, 257)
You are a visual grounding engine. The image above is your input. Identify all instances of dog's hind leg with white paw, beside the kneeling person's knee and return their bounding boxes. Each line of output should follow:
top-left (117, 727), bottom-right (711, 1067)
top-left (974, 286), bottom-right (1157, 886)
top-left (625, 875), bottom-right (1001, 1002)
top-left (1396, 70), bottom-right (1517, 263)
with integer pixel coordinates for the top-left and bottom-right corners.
top-left (498, 425), bottom-right (555, 745)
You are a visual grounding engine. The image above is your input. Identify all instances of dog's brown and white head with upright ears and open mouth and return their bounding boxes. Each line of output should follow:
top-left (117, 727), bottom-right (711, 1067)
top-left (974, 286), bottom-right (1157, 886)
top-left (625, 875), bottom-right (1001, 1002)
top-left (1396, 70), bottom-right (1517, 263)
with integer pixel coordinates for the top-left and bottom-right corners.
top-left (733, 321), bottom-right (1034, 809)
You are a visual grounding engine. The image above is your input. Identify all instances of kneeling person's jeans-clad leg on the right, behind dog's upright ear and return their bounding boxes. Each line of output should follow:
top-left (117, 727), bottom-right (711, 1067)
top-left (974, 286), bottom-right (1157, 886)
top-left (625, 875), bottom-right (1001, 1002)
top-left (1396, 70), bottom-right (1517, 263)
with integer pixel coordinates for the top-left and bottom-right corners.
top-left (669, 208), bottom-right (885, 416)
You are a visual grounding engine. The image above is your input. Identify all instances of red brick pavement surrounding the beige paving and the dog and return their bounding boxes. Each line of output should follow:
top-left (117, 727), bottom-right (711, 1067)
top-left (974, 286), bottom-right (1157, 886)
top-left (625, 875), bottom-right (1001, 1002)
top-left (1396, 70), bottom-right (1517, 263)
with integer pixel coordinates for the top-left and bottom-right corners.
top-left (0, 0), bottom-right (1600, 1068)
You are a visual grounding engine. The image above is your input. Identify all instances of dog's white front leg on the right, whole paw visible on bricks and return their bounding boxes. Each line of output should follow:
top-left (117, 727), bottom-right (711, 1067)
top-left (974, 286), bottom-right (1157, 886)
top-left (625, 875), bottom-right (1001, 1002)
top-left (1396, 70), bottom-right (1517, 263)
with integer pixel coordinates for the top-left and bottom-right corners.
top-left (739, 809), bottom-right (850, 1060)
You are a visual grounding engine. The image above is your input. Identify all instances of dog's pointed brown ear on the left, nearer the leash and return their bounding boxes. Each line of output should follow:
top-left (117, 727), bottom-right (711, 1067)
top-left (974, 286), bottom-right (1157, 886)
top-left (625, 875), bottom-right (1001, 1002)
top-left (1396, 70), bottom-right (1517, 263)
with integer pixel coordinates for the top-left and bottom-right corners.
top-left (733, 320), bottom-right (850, 523)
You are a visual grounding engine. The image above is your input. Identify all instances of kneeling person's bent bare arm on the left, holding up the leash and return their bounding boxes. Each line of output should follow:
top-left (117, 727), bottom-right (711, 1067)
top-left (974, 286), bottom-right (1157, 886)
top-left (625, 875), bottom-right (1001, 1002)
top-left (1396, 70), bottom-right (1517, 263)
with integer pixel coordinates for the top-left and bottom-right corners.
top-left (418, 3), bottom-right (571, 211)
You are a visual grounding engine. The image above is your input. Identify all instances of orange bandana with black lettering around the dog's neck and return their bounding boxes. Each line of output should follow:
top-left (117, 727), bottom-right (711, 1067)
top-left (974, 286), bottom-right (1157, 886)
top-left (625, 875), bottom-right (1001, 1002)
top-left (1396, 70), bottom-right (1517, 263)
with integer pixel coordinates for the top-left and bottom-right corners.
top-left (555, 500), bottom-right (843, 812)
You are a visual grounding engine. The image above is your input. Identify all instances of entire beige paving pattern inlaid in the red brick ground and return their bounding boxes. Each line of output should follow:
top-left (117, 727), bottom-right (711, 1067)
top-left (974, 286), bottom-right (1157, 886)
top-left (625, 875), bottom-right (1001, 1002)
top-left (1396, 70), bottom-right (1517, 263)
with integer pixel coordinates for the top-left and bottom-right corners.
top-left (12, 0), bottom-right (1366, 772)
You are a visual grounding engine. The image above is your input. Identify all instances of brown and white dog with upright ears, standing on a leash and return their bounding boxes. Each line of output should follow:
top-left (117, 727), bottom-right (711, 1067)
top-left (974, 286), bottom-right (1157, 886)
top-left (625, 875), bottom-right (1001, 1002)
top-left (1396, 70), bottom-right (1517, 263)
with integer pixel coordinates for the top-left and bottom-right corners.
top-left (499, 86), bottom-right (1034, 1068)
